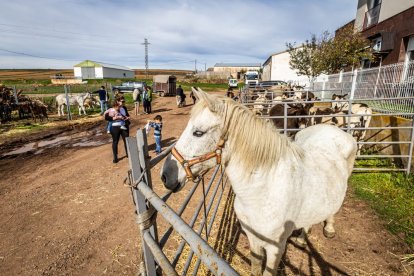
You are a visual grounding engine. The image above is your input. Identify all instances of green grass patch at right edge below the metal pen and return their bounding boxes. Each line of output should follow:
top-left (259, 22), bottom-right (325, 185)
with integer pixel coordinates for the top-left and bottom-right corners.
top-left (350, 173), bottom-right (414, 250)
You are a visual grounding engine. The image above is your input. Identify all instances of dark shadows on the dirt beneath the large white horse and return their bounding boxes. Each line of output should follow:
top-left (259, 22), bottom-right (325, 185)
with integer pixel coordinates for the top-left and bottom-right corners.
top-left (214, 189), bottom-right (349, 275)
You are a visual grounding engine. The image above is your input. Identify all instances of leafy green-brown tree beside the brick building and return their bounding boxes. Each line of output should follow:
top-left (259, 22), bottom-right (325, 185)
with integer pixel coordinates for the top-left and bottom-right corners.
top-left (286, 25), bottom-right (373, 79)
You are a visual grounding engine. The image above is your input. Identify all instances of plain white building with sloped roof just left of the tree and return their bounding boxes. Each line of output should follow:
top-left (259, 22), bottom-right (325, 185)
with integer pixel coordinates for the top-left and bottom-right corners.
top-left (262, 51), bottom-right (308, 85)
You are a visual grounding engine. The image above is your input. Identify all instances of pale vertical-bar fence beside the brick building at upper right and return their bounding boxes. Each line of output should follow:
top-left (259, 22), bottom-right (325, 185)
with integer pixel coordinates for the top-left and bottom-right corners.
top-left (310, 61), bottom-right (414, 116)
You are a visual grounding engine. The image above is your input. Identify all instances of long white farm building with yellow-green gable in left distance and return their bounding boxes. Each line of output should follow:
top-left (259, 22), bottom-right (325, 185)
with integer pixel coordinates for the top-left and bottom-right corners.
top-left (73, 60), bottom-right (135, 79)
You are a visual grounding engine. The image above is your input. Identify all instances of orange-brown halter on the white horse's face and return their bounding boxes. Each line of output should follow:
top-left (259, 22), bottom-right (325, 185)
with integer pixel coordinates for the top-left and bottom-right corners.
top-left (171, 138), bottom-right (225, 181)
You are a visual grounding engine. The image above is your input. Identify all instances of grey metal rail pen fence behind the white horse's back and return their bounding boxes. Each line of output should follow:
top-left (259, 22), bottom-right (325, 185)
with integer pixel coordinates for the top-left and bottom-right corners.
top-left (240, 88), bottom-right (414, 174)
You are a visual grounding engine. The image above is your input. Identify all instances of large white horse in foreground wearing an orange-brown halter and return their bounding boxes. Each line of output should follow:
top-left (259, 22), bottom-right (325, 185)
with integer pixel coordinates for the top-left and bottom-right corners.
top-left (161, 88), bottom-right (357, 275)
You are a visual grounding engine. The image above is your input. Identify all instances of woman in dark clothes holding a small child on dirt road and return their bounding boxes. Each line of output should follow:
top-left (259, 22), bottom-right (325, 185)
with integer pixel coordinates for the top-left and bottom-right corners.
top-left (105, 98), bottom-right (130, 163)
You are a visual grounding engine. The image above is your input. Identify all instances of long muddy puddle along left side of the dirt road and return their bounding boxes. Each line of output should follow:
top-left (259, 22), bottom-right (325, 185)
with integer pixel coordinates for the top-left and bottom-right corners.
top-left (1, 130), bottom-right (111, 157)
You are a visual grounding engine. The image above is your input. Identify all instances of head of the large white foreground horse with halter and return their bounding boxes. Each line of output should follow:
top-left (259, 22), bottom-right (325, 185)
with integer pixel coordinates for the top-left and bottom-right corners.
top-left (161, 88), bottom-right (226, 190)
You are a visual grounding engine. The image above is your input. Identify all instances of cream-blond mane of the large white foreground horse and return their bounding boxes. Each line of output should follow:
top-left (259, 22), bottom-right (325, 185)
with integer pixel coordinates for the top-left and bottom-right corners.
top-left (191, 92), bottom-right (303, 175)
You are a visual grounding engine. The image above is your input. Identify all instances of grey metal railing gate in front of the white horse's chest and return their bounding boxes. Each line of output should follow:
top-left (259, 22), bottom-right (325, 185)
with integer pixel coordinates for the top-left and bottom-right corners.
top-left (126, 129), bottom-right (237, 275)
